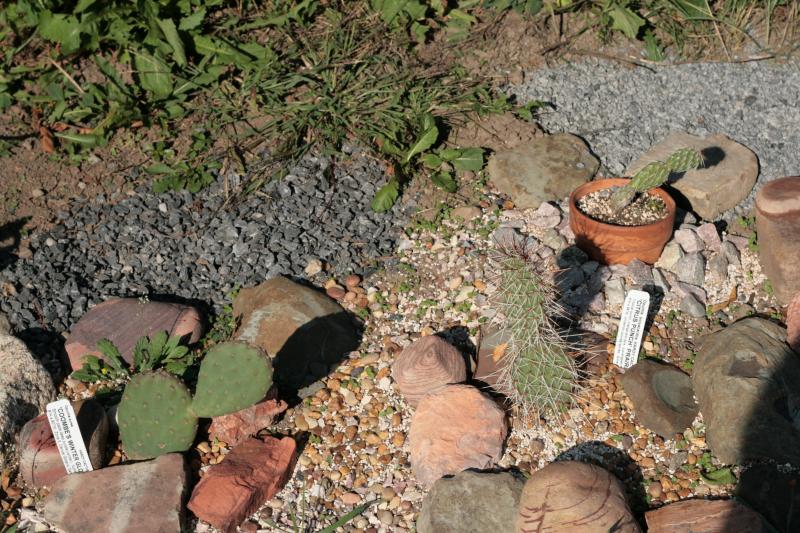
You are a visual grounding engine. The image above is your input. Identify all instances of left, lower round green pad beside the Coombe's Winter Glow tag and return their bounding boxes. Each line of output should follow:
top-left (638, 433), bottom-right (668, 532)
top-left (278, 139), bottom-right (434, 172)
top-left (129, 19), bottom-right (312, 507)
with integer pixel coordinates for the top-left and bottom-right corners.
top-left (118, 372), bottom-right (197, 459)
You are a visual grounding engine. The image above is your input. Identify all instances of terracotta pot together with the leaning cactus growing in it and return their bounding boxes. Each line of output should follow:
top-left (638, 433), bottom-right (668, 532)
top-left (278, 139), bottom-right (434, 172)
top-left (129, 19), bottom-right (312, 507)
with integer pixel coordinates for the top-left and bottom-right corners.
top-left (569, 148), bottom-right (703, 265)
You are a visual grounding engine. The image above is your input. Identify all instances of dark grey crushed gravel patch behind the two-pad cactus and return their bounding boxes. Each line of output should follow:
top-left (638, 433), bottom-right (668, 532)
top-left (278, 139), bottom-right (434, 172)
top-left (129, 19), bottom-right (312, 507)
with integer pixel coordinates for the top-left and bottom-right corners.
top-left (0, 149), bottom-right (406, 332)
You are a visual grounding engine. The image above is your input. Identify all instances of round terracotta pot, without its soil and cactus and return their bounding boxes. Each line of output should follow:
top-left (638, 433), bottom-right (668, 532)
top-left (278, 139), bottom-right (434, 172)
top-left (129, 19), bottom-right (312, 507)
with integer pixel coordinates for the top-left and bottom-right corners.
top-left (569, 178), bottom-right (675, 265)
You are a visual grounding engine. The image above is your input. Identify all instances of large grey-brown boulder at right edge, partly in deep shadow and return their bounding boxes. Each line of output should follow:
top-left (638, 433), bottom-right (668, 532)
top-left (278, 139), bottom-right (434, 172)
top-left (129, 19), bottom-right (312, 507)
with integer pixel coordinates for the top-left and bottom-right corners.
top-left (692, 317), bottom-right (800, 466)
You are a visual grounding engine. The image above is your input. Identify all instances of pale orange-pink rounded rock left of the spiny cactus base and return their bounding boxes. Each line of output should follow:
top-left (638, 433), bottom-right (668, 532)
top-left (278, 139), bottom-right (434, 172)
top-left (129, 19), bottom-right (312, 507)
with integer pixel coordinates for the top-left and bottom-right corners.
top-left (408, 385), bottom-right (508, 486)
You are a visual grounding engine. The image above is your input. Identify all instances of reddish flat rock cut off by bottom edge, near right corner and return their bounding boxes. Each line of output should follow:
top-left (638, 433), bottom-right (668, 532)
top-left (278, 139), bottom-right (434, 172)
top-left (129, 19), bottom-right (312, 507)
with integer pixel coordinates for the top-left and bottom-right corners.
top-left (644, 500), bottom-right (773, 533)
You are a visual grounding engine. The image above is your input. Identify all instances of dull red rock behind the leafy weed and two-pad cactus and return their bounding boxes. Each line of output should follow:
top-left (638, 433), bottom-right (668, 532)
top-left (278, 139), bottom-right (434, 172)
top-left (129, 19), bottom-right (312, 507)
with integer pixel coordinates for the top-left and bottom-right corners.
top-left (64, 298), bottom-right (203, 370)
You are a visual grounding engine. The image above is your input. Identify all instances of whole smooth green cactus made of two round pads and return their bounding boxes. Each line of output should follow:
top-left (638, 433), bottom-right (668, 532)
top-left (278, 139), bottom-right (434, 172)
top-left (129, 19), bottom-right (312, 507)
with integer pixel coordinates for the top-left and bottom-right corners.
top-left (118, 342), bottom-right (272, 459)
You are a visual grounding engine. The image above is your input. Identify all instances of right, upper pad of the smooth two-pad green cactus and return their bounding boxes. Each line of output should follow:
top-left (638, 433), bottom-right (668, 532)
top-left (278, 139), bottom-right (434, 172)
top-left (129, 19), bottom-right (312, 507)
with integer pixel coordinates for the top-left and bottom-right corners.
top-left (192, 342), bottom-right (272, 418)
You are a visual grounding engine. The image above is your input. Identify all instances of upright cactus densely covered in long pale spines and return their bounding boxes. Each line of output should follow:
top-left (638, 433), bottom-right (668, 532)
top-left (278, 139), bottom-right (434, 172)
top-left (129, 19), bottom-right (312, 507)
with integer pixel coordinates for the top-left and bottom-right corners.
top-left (492, 242), bottom-right (580, 418)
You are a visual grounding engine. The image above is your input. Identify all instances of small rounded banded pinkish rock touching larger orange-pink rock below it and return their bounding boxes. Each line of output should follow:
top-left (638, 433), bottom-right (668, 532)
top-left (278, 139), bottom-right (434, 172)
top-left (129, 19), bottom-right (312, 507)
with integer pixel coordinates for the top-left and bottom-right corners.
top-left (392, 335), bottom-right (467, 406)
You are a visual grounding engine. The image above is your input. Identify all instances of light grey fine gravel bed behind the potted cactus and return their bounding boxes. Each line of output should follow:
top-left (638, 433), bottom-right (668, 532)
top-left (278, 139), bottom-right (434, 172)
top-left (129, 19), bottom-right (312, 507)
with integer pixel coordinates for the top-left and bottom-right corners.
top-left (508, 60), bottom-right (800, 211)
